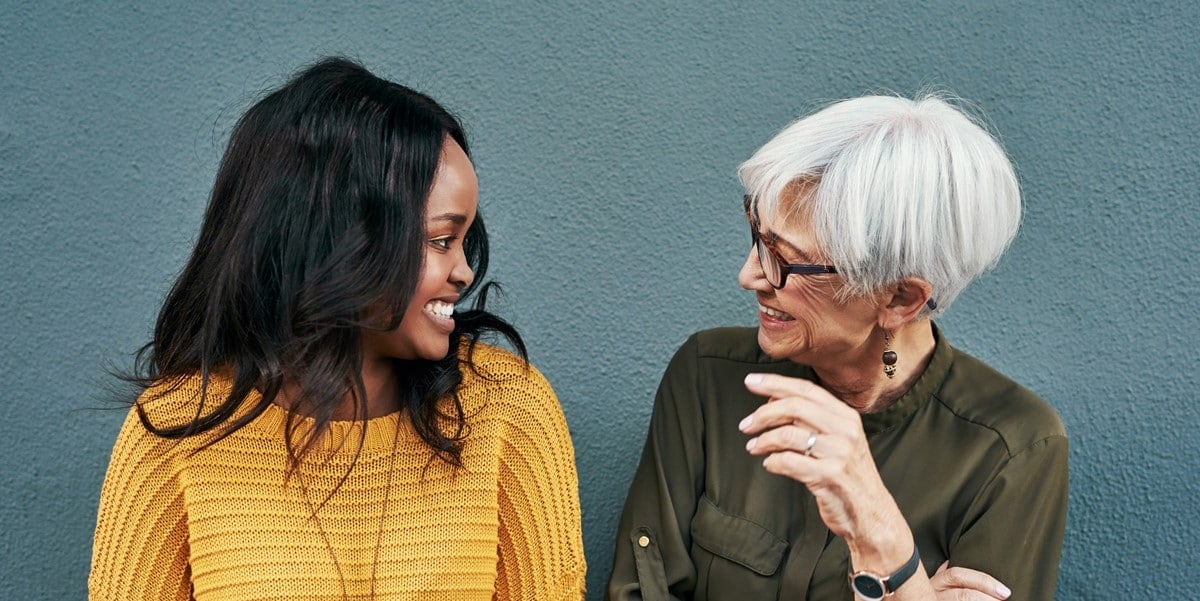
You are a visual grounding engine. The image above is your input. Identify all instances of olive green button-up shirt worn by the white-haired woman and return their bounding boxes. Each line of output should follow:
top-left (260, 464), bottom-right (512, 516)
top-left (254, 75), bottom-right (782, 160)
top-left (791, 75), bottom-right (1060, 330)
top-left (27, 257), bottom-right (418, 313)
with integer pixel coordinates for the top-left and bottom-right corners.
top-left (607, 327), bottom-right (1067, 601)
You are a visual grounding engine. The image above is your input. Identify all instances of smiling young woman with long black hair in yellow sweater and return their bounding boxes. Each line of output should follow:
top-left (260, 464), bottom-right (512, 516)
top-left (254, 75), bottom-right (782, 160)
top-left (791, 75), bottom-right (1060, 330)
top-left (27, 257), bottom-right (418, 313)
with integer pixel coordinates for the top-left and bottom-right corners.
top-left (89, 59), bottom-right (584, 600)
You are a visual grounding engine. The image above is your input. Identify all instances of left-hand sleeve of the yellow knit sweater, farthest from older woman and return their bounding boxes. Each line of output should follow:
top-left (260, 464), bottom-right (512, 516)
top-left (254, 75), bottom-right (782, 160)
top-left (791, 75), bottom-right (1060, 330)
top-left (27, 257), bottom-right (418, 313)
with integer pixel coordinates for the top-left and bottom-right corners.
top-left (88, 409), bottom-right (192, 601)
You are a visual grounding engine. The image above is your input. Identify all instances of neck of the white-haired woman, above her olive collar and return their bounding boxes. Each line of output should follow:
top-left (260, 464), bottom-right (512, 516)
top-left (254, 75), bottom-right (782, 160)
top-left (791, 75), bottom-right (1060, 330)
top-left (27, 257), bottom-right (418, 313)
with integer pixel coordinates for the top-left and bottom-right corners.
top-left (812, 319), bottom-right (936, 413)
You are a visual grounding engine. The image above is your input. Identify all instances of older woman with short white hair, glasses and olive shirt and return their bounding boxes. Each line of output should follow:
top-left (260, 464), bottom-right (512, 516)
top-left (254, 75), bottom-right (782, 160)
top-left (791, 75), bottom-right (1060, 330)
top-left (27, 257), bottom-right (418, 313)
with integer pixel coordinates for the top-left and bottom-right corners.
top-left (607, 96), bottom-right (1067, 601)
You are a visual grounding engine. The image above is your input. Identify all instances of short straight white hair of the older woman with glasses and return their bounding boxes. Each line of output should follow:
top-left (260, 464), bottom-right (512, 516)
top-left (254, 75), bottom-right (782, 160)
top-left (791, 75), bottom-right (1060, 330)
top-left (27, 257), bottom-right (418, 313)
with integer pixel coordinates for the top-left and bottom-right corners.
top-left (738, 95), bottom-right (1021, 312)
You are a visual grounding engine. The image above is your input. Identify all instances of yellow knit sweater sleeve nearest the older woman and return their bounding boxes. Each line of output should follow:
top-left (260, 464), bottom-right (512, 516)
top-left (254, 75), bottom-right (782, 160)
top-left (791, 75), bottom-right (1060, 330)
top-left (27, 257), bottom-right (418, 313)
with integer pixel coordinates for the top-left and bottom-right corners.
top-left (488, 359), bottom-right (587, 601)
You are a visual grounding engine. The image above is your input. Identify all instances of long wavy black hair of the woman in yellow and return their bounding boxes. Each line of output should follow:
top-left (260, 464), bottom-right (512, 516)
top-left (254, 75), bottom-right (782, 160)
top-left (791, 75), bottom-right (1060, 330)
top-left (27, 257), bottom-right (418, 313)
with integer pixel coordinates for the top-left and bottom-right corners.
top-left (126, 58), bottom-right (527, 467)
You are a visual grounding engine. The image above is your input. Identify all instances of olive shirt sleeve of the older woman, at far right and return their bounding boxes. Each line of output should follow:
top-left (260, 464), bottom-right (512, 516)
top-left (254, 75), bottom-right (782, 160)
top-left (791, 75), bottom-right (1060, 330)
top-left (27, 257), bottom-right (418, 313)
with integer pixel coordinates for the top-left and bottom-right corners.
top-left (949, 435), bottom-right (1068, 600)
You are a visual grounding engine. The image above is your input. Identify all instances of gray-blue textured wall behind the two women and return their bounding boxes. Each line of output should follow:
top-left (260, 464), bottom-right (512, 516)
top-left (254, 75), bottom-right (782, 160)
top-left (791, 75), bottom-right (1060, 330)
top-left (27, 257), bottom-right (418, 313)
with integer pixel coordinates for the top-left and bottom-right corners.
top-left (0, 0), bottom-right (1200, 599)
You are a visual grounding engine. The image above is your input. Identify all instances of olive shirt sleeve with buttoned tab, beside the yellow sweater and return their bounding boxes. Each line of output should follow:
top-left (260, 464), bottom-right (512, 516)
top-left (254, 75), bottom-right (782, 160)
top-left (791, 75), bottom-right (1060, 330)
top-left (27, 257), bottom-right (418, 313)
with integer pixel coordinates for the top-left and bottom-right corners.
top-left (606, 336), bottom-right (704, 601)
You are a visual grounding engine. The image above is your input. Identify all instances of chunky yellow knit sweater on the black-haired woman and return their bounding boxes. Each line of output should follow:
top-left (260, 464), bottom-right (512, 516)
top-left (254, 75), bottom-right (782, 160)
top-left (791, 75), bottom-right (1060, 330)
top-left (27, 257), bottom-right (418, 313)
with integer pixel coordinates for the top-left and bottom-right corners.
top-left (89, 344), bottom-right (584, 601)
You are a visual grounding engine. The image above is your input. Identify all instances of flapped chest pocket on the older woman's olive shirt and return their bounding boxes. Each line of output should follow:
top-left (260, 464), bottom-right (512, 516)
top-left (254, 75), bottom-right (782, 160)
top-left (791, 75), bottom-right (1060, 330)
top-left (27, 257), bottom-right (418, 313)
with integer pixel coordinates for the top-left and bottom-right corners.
top-left (691, 497), bottom-right (787, 601)
